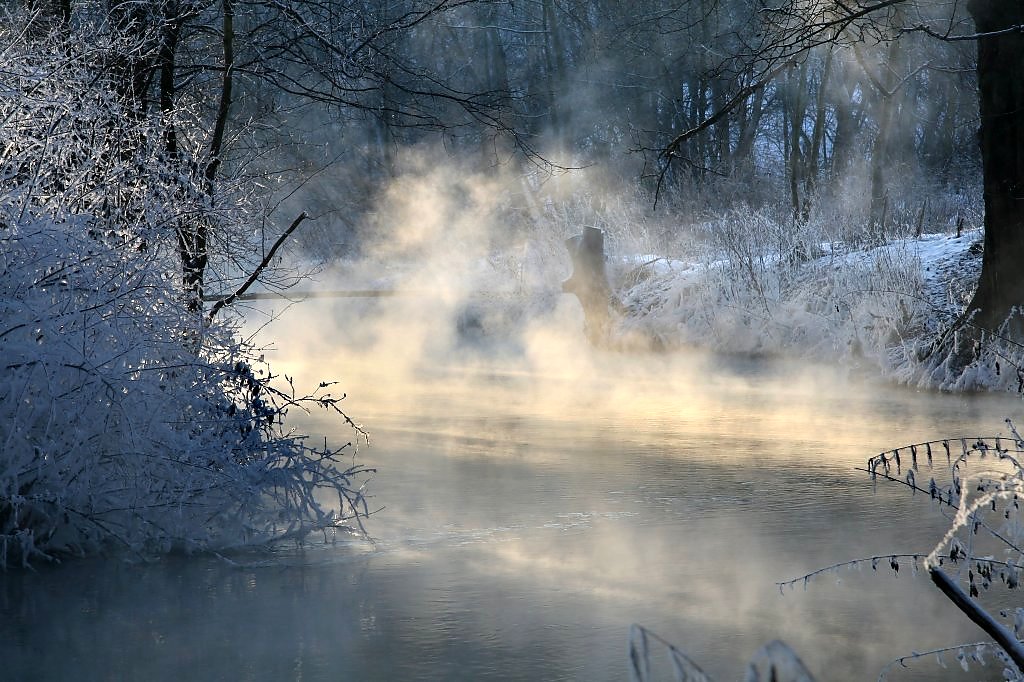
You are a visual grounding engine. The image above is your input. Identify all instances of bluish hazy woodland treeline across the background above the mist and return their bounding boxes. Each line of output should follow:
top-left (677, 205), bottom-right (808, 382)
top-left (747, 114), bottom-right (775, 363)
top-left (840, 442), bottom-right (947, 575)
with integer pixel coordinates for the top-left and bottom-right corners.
top-left (14, 0), bottom-right (980, 251)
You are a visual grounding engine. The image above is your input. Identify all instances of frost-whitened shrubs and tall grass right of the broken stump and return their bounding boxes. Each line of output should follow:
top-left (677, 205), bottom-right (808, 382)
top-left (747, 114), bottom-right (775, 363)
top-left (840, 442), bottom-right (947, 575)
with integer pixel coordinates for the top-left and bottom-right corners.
top-left (621, 211), bottom-right (935, 365)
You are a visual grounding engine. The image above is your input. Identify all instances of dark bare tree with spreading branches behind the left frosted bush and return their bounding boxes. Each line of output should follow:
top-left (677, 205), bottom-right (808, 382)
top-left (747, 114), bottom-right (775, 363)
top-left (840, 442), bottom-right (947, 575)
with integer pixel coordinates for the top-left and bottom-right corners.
top-left (12, 0), bottom-right (539, 311)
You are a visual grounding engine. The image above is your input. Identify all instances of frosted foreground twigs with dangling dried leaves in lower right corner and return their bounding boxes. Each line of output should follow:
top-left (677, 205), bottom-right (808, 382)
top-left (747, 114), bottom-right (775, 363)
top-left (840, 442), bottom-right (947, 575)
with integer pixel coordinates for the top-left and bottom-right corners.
top-left (839, 420), bottom-right (1024, 680)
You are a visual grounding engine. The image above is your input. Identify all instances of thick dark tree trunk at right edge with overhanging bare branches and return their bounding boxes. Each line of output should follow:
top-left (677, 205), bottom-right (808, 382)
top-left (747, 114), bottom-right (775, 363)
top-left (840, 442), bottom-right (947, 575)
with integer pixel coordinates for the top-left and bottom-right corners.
top-left (647, 0), bottom-right (1024, 376)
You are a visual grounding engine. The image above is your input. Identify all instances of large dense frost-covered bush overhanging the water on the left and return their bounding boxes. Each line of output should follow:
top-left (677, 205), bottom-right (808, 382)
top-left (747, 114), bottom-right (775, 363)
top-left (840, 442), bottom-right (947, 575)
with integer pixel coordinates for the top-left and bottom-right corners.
top-left (0, 220), bottom-right (361, 566)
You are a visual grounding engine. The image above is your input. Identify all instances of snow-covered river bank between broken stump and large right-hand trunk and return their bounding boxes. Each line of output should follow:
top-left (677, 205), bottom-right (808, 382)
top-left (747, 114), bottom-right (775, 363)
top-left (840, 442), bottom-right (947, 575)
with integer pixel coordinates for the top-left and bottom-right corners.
top-left (612, 229), bottom-right (999, 390)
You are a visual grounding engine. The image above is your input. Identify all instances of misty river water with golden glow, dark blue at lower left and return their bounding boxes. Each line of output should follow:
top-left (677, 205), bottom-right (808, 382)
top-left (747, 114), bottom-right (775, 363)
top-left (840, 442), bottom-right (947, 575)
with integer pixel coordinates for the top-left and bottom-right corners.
top-left (0, 303), bottom-right (1021, 681)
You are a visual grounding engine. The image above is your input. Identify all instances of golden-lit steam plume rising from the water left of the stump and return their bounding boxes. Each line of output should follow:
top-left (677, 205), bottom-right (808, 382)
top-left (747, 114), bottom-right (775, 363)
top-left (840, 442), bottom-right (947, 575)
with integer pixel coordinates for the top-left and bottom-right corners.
top-left (249, 146), bottom-right (618, 394)
